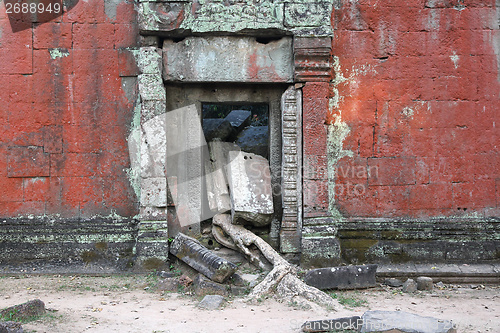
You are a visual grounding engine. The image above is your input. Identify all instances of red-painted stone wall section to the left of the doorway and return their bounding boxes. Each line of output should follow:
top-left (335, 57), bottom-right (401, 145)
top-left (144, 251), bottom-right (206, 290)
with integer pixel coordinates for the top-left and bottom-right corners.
top-left (0, 0), bottom-right (138, 217)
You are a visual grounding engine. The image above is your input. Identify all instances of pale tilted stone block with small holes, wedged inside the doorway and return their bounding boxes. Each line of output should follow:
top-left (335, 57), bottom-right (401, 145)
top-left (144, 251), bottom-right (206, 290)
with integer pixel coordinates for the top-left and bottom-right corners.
top-left (227, 151), bottom-right (274, 227)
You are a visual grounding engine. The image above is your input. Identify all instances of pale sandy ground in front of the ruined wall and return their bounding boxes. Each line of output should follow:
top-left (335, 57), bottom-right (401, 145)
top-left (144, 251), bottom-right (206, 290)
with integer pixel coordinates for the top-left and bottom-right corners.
top-left (0, 275), bottom-right (500, 333)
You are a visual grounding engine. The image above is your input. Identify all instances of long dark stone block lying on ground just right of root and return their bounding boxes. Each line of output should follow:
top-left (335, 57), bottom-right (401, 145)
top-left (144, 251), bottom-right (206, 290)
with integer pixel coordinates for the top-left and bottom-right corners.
top-left (304, 265), bottom-right (377, 289)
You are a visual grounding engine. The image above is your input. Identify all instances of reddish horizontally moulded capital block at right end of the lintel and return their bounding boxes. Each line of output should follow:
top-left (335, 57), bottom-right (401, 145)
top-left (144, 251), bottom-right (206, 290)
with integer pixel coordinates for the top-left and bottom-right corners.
top-left (293, 37), bottom-right (332, 82)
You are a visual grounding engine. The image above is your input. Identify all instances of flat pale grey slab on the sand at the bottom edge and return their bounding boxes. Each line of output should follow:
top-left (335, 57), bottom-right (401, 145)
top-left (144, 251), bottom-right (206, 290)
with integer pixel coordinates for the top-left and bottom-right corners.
top-left (360, 311), bottom-right (457, 333)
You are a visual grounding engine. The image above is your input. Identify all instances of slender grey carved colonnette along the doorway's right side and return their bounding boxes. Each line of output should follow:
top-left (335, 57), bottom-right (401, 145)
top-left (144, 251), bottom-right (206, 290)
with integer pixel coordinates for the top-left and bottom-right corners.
top-left (280, 87), bottom-right (302, 253)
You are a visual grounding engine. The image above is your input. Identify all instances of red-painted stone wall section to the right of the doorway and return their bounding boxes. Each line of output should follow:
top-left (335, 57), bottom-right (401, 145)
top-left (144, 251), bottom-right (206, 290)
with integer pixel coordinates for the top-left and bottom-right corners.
top-left (324, 0), bottom-right (500, 218)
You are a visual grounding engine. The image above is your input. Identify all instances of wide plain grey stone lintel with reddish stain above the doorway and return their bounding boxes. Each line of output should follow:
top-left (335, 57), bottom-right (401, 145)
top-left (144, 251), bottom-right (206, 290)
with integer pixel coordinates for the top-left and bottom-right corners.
top-left (163, 37), bottom-right (293, 82)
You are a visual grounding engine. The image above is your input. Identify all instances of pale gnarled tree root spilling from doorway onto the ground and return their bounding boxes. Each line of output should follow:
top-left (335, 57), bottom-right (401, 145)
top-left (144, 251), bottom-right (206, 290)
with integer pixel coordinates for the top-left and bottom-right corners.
top-left (212, 214), bottom-right (339, 310)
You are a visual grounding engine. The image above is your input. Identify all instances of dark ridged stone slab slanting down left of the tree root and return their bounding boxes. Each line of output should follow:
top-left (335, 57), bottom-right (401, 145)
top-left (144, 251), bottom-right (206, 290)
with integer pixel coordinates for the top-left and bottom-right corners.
top-left (170, 233), bottom-right (238, 283)
